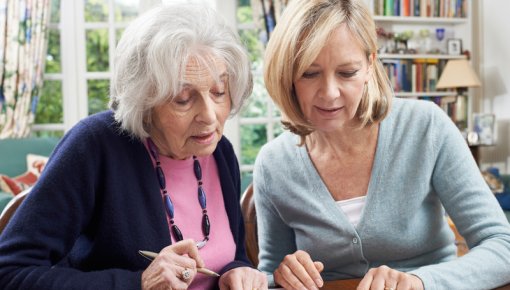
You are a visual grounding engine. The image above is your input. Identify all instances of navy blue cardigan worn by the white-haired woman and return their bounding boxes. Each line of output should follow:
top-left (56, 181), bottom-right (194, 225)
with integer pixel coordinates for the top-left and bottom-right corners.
top-left (0, 111), bottom-right (250, 290)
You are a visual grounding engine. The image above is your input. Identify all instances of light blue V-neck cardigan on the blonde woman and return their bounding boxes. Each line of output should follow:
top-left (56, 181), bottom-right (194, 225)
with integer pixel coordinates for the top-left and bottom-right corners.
top-left (253, 99), bottom-right (510, 290)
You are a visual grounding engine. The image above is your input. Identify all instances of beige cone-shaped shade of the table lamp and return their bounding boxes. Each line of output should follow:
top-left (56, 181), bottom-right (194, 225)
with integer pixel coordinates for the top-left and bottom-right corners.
top-left (436, 59), bottom-right (481, 89)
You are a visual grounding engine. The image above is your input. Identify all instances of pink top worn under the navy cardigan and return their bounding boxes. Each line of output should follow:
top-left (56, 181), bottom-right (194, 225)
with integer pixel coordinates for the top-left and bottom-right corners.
top-left (147, 148), bottom-right (236, 289)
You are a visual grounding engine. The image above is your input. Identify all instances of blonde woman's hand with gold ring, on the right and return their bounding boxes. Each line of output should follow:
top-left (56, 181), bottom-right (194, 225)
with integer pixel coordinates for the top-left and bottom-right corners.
top-left (357, 266), bottom-right (424, 290)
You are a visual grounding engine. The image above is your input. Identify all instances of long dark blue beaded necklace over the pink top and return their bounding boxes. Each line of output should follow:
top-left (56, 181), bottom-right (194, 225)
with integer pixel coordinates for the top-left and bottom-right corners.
top-left (147, 138), bottom-right (211, 249)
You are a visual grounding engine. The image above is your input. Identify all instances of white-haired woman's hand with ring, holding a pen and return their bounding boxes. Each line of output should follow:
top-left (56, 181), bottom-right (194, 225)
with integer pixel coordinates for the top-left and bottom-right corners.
top-left (142, 240), bottom-right (204, 290)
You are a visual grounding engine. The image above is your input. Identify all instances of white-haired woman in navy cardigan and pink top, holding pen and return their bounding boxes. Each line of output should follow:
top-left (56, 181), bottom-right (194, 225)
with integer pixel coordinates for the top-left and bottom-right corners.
top-left (0, 4), bottom-right (267, 290)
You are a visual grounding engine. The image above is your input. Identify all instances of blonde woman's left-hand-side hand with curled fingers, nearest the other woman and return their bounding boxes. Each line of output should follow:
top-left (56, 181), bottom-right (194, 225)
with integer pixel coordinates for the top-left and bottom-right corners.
top-left (274, 250), bottom-right (324, 289)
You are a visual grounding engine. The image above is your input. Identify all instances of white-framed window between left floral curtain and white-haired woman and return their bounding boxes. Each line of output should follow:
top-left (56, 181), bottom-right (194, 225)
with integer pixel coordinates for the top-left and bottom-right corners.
top-left (34, 0), bottom-right (139, 136)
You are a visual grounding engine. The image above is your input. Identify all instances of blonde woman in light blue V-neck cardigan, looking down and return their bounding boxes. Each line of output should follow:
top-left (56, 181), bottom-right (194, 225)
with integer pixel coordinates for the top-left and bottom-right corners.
top-left (254, 0), bottom-right (510, 290)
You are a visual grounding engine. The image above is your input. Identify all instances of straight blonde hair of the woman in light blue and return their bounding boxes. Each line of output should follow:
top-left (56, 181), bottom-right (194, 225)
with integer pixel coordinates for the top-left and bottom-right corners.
top-left (264, 0), bottom-right (393, 144)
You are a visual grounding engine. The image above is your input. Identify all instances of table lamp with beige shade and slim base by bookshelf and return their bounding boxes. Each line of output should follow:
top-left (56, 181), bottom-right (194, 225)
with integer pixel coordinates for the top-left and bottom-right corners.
top-left (436, 59), bottom-right (481, 130)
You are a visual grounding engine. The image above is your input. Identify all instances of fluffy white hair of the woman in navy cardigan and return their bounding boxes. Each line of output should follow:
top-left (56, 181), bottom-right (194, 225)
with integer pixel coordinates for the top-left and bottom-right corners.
top-left (110, 2), bottom-right (253, 138)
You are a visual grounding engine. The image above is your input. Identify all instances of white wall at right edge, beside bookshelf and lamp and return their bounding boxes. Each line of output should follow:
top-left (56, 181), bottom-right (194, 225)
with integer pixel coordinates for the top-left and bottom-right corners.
top-left (475, 0), bottom-right (510, 173)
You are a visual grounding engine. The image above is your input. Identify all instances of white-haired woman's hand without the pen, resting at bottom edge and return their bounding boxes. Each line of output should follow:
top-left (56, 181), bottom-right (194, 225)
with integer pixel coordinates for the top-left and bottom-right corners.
top-left (219, 267), bottom-right (268, 290)
